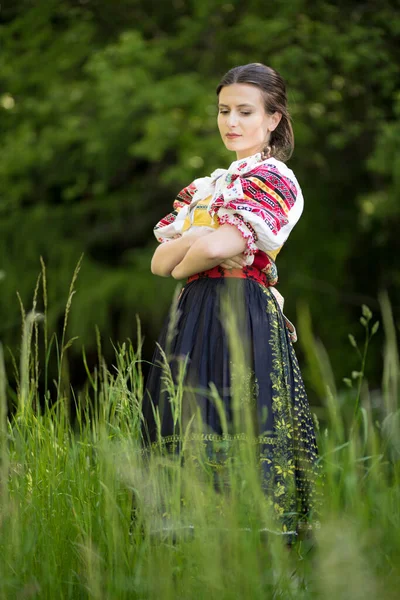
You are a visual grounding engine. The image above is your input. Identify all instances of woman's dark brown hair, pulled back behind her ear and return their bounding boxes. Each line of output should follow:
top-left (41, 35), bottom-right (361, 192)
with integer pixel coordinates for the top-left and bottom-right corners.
top-left (217, 63), bottom-right (294, 161)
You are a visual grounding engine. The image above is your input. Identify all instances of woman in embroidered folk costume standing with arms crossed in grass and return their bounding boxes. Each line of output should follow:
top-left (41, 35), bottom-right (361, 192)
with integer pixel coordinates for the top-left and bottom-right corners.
top-left (144, 63), bottom-right (318, 529)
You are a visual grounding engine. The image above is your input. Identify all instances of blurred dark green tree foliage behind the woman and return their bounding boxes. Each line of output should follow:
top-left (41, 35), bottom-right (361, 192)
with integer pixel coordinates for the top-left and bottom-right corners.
top-left (0, 0), bottom-right (400, 402)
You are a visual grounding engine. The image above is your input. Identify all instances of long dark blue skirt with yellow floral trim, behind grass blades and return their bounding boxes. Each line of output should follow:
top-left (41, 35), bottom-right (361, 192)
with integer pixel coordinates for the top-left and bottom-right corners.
top-left (143, 278), bottom-right (319, 530)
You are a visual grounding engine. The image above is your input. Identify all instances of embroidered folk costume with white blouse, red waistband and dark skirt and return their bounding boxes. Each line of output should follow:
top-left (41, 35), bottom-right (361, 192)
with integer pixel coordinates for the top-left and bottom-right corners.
top-left (144, 154), bottom-right (318, 530)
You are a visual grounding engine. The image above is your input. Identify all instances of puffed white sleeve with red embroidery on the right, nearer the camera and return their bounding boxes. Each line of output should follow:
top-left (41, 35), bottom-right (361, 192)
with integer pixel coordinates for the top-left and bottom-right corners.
top-left (209, 159), bottom-right (304, 255)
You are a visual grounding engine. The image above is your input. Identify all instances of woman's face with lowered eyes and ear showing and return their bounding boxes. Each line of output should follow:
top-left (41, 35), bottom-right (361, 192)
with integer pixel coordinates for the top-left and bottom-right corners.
top-left (218, 83), bottom-right (281, 160)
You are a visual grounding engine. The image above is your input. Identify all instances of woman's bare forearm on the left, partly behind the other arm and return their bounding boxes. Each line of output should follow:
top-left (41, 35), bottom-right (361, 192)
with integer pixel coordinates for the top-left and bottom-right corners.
top-left (151, 227), bottom-right (211, 277)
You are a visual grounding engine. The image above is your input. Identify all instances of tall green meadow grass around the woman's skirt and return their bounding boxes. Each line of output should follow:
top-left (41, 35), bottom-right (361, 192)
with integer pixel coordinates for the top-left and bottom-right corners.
top-left (0, 267), bottom-right (400, 600)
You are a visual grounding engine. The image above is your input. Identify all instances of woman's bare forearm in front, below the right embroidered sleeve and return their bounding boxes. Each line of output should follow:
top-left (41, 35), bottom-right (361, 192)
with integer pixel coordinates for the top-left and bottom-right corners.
top-left (171, 225), bottom-right (246, 279)
